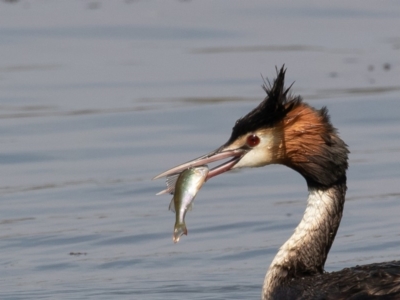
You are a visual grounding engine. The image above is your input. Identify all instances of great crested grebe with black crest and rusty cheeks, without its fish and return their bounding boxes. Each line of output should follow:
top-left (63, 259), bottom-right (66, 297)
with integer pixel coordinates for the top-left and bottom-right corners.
top-left (155, 67), bottom-right (400, 300)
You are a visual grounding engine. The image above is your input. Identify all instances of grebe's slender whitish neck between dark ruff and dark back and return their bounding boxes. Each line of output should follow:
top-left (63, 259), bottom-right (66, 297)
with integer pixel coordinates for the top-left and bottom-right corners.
top-left (263, 175), bottom-right (346, 300)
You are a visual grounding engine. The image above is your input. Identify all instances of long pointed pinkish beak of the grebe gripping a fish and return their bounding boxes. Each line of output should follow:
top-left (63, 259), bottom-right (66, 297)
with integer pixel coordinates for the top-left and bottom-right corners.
top-left (153, 146), bottom-right (248, 180)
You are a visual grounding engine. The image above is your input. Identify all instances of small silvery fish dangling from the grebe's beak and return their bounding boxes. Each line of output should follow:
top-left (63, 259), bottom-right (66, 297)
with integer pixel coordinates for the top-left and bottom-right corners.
top-left (167, 166), bottom-right (209, 243)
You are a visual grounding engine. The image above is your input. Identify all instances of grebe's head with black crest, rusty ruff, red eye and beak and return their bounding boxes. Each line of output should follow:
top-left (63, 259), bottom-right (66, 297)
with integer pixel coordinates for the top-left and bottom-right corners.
top-left (154, 67), bottom-right (348, 186)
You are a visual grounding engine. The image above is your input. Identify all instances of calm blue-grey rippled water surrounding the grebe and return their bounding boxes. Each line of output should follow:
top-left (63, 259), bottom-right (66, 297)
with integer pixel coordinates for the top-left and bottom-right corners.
top-left (0, 0), bottom-right (400, 300)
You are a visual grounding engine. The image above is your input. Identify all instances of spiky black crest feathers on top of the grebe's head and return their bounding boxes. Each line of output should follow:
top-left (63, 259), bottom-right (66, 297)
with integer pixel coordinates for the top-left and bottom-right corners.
top-left (227, 65), bottom-right (301, 143)
